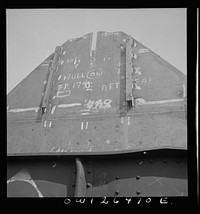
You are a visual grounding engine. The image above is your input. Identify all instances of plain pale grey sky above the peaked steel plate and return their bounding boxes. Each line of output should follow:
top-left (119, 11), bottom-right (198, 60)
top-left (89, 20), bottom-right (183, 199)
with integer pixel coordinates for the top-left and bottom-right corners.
top-left (6, 8), bottom-right (187, 93)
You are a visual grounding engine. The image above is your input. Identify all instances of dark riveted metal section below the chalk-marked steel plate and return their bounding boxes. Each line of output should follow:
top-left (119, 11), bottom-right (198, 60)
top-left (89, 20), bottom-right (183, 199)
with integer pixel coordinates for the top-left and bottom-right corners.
top-left (7, 150), bottom-right (188, 197)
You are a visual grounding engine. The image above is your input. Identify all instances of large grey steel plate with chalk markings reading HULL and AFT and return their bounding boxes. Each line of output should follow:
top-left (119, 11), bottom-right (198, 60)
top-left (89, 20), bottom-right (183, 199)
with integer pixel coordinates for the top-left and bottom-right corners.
top-left (7, 32), bottom-right (187, 155)
